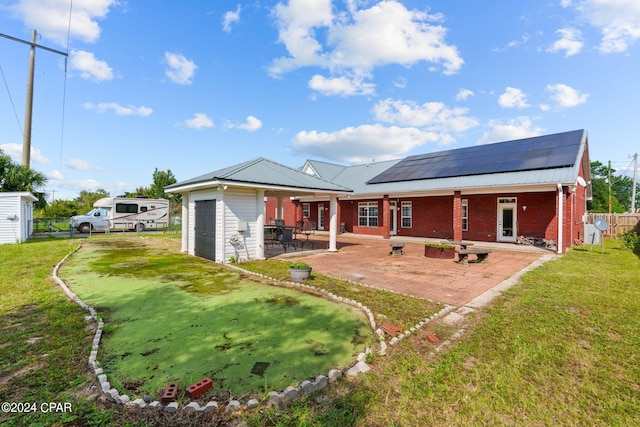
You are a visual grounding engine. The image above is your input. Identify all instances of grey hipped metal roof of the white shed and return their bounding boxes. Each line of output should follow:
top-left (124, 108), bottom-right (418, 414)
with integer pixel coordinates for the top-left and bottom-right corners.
top-left (165, 157), bottom-right (351, 192)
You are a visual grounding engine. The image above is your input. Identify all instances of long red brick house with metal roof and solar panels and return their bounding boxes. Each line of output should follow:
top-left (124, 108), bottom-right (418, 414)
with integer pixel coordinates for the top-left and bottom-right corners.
top-left (265, 130), bottom-right (591, 253)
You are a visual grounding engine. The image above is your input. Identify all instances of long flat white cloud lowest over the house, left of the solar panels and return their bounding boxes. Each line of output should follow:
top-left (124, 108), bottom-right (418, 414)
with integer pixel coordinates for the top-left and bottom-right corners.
top-left (292, 124), bottom-right (439, 163)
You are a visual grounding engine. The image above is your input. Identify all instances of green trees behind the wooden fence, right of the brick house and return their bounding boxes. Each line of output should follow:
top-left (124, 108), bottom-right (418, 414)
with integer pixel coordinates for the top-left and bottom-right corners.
top-left (589, 161), bottom-right (633, 213)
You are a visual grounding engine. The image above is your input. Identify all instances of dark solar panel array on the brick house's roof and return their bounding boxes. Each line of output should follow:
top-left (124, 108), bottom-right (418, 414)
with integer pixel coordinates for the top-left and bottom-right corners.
top-left (367, 130), bottom-right (584, 184)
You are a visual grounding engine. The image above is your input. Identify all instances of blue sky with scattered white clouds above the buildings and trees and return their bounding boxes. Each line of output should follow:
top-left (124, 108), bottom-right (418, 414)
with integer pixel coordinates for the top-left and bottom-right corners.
top-left (0, 0), bottom-right (640, 199)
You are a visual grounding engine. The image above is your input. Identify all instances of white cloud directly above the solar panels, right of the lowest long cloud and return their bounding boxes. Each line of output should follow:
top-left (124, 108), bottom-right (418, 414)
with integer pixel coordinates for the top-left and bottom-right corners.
top-left (373, 99), bottom-right (478, 133)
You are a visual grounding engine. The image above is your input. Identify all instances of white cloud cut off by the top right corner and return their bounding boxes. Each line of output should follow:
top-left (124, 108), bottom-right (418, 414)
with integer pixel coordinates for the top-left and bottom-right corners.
top-left (561, 0), bottom-right (640, 53)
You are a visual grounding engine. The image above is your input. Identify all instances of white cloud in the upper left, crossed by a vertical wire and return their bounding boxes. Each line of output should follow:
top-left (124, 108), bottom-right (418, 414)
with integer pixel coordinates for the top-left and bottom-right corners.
top-left (9, 0), bottom-right (118, 46)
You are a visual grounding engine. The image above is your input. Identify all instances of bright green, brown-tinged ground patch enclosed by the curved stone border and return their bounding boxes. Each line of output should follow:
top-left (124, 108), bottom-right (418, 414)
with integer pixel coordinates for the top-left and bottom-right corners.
top-left (61, 238), bottom-right (372, 399)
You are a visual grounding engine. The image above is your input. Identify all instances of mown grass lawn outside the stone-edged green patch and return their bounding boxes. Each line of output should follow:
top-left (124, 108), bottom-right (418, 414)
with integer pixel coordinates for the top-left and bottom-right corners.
top-left (0, 236), bottom-right (640, 426)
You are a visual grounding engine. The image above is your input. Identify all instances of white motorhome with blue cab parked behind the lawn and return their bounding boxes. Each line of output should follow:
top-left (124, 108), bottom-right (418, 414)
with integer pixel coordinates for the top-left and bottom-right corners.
top-left (71, 197), bottom-right (169, 233)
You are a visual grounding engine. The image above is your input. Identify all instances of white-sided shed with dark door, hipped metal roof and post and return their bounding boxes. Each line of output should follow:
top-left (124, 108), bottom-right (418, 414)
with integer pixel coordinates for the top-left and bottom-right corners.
top-left (165, 158), bottom-right (351, 262)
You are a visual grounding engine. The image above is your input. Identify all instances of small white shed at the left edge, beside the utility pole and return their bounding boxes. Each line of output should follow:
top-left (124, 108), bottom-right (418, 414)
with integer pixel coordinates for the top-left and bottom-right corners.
top-left (0, 192), bottom-right (38, 244)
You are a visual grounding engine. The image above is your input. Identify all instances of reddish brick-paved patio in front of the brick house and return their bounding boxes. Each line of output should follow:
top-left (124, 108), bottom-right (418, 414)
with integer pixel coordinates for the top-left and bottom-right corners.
top-left (265, 233), bottom-right (553, 306)
